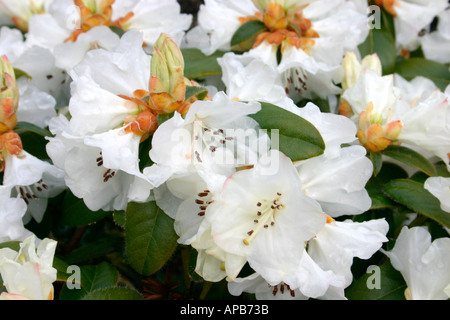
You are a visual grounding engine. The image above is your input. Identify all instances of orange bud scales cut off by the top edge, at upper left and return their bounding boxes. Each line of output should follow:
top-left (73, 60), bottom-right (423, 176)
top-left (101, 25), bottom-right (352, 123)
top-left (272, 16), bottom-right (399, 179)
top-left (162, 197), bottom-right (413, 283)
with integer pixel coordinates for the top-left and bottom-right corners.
top-left (65, 0), bottom-right (134, 42)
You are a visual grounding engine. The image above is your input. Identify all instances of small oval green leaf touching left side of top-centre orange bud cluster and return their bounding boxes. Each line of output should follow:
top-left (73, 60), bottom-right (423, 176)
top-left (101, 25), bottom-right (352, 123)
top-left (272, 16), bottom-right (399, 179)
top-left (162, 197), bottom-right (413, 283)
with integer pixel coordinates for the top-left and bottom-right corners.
top-left (230, 20), bottom-right (268, 52)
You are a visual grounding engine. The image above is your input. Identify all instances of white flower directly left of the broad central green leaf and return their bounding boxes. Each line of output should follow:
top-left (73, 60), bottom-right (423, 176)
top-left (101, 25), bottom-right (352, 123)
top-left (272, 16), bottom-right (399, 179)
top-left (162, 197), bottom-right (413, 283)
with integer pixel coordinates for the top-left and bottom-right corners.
top-left (144, 92), bottom-right (268, 186)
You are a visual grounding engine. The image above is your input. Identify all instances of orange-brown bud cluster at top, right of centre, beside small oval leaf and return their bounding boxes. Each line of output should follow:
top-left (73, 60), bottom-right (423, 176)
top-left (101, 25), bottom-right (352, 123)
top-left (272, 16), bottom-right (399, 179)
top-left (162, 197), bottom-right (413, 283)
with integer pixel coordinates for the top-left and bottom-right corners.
top-left (239, 2), bottom-right (319, 54)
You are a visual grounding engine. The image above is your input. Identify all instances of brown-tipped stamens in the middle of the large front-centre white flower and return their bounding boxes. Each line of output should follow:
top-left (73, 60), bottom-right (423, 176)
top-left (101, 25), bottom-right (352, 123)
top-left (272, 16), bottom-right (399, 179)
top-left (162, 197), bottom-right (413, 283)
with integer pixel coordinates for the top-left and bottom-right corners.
top-left (244, 192), bottom-right (284, 245)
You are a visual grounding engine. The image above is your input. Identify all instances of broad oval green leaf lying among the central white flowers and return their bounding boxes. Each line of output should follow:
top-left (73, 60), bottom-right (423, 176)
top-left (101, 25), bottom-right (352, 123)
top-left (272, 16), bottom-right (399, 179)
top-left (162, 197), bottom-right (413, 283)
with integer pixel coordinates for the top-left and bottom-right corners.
top-left (250, 102), bottom-right (325, 161)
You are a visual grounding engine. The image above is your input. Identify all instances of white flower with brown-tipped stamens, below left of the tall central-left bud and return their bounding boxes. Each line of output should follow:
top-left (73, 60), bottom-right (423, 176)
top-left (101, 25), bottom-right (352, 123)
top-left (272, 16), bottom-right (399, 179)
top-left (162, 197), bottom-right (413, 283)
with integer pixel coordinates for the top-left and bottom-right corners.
top-left (46, 115), bottom-right (150, 211)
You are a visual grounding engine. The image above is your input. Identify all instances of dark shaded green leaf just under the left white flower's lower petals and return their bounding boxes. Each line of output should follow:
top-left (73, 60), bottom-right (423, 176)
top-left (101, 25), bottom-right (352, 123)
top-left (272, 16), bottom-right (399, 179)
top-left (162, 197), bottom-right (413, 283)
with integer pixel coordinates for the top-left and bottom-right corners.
top-left (62, 190), bottom-right (111, 227)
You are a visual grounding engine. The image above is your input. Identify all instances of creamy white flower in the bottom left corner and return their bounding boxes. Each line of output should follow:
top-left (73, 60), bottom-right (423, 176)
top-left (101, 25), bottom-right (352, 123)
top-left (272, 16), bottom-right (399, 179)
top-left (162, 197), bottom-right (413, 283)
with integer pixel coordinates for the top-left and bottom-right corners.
top-left (0, 235), bottom-right (57, 300)
